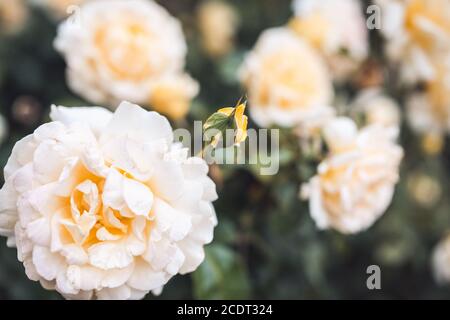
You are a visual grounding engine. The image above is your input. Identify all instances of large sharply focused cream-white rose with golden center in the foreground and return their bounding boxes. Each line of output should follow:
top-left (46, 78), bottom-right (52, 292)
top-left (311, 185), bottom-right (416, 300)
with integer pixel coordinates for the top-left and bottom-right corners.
top-left (0, 102), bottom-right (217, 299)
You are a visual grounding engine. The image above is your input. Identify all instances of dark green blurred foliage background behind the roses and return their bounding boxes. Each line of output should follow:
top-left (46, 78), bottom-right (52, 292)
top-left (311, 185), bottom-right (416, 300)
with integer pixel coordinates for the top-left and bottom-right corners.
top-left (0, 0), bottom-right (450, 299)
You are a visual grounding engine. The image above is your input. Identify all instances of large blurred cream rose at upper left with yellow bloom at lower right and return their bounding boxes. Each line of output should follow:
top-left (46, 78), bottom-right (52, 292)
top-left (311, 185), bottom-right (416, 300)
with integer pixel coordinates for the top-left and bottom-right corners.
top-left (55, 0), bottom-right (198, 119)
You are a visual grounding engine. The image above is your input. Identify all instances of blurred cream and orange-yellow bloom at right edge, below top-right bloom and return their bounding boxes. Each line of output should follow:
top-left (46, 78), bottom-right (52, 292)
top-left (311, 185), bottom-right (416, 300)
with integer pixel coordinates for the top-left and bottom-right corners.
top-left (407, 60), bottom-right (450, 134)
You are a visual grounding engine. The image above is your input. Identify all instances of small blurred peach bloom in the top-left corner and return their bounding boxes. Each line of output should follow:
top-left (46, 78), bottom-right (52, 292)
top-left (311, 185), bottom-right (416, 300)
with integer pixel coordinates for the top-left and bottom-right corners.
top-left (0, 0), bottom-right (28, 34)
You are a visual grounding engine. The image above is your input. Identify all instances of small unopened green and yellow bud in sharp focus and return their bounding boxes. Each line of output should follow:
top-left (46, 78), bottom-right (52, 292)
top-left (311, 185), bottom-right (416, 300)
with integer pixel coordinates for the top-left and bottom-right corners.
top-left (203, 103), bottom-right (248, 146)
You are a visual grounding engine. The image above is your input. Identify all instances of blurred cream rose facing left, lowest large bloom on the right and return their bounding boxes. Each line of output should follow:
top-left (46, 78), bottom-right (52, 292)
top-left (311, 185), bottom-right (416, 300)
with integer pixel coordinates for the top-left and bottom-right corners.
top-left (302, 118), bottom-right (403, 233)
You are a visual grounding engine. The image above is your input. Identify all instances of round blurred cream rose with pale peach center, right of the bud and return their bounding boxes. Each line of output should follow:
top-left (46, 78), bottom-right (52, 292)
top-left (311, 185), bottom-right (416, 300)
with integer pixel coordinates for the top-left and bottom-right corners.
top-left (240, 28), bottom-right (333, 127)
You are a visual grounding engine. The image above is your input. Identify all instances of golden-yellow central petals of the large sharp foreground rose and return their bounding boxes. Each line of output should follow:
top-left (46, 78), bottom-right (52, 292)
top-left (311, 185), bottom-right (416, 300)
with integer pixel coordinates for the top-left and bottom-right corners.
top-left (61, 165), bottom-right (152, 249)
